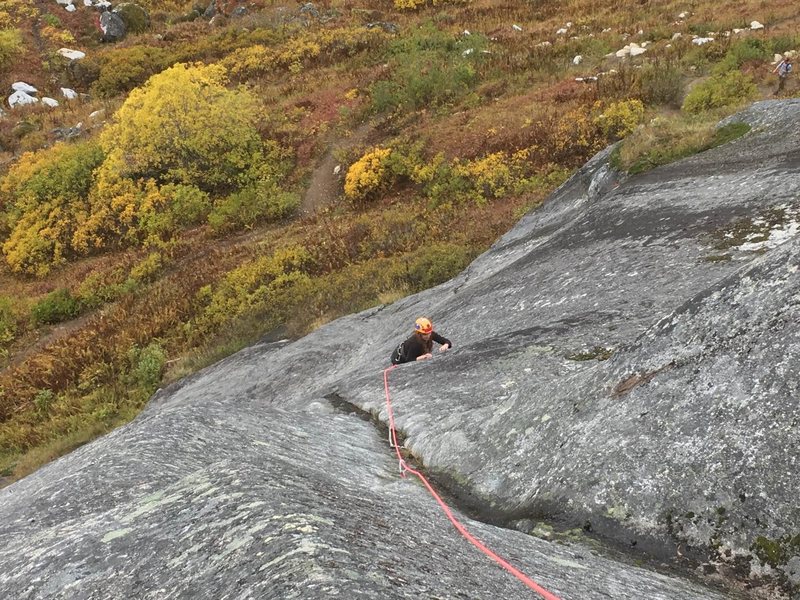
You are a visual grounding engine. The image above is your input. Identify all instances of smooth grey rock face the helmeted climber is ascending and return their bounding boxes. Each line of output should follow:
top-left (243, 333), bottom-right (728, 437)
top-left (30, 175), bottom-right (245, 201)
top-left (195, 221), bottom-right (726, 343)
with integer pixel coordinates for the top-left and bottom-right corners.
top-left (0, 101), bottom-right (800, 600)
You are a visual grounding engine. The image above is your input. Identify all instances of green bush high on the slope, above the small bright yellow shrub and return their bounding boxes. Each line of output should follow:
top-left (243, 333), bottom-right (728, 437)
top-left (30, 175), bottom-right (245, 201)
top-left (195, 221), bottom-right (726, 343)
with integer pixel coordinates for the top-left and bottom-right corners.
top-left (370, 23), bottom-right (486, 113)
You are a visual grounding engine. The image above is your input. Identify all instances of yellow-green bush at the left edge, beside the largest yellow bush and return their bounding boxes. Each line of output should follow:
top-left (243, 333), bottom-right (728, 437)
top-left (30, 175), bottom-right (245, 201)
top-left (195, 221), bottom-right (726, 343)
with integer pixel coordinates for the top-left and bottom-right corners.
top-left (0, 141), bottom-right (104, 276)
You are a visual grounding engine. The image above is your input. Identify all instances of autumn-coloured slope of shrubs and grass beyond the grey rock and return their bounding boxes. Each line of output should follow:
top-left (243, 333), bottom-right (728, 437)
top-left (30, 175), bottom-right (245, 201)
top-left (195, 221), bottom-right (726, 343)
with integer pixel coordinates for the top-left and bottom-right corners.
top-left (0, 0), bottom-right (800, 488)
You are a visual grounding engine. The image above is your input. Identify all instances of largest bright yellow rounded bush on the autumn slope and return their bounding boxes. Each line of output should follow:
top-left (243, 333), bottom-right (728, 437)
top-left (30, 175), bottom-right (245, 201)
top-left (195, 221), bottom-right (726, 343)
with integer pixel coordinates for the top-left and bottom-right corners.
top-left (101, 64), bottom-right (264, 192)
